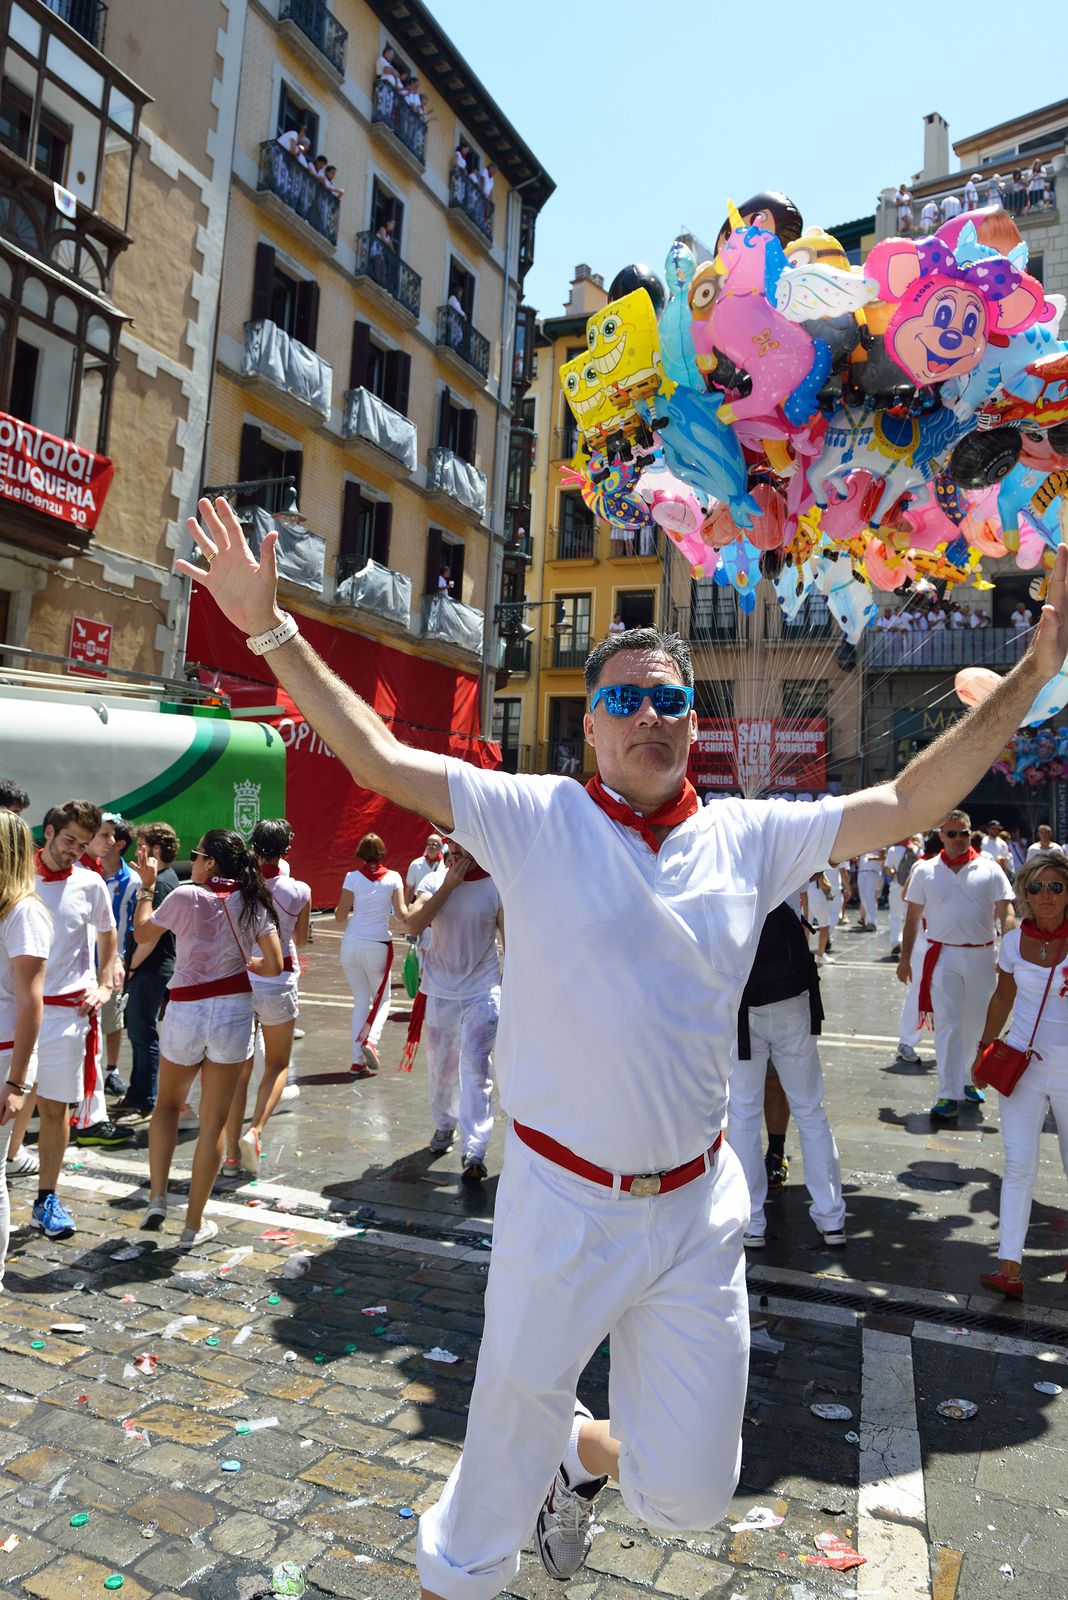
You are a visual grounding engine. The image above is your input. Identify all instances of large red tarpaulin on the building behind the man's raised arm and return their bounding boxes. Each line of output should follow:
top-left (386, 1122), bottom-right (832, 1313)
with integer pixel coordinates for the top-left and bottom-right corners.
top-left (185, 587), bottom-right (500, 906)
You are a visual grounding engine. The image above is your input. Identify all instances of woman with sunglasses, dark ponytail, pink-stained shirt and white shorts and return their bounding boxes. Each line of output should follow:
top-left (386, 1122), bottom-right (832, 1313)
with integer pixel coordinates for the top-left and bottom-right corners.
top-left (134, 827), bottom-right (281, 1250)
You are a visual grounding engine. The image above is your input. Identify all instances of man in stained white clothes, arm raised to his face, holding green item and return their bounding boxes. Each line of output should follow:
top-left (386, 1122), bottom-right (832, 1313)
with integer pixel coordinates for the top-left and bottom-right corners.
top-left (408, 840), bottom-right (504, 1184)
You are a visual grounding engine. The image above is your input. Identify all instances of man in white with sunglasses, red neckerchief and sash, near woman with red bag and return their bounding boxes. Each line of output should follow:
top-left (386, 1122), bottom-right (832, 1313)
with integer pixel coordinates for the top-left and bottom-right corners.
top-left (897, 810), bottom-right (1015, 1122)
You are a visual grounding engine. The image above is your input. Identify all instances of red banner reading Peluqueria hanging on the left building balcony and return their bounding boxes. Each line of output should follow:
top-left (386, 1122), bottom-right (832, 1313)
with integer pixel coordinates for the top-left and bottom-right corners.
top-left (0, 411), bottom-right (115, 530)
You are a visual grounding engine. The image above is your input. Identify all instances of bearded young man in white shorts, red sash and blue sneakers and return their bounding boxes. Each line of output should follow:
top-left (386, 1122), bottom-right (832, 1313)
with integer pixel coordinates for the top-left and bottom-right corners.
top-left (34, 800), bottom-right (117, 1238)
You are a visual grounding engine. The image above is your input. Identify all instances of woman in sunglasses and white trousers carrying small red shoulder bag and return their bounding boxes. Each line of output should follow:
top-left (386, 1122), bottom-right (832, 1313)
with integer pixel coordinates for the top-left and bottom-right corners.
top-left (972, 851), bottom-right (1068, 1299)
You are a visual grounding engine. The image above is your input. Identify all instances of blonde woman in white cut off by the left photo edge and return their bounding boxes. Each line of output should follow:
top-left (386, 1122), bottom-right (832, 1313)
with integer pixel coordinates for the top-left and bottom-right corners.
top-left (0, 811), bottom-right (51, 1286)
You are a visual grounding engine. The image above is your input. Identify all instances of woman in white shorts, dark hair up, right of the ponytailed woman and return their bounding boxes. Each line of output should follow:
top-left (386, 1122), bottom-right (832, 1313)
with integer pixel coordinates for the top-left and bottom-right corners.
top-left (222, 818), bottom-right (312, 1178)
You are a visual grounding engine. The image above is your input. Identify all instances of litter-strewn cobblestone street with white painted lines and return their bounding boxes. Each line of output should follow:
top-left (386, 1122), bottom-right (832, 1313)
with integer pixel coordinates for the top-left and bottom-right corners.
top-left (0, 923), bottom-right (1068, 1600)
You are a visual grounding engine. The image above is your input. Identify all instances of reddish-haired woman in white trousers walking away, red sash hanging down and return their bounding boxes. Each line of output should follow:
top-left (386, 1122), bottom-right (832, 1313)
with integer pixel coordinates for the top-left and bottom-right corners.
top-left (334, 834), bottom-right (408, 1077)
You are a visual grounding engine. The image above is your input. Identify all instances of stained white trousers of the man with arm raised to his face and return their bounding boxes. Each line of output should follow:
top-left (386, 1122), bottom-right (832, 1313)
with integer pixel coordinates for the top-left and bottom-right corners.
top-left (422, 986), bottom-right (500, 1162)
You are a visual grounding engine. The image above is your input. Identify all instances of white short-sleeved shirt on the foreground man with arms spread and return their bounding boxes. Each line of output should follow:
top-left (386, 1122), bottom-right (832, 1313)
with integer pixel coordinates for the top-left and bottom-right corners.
top-left (446, 758), bottom-right (841, 1173)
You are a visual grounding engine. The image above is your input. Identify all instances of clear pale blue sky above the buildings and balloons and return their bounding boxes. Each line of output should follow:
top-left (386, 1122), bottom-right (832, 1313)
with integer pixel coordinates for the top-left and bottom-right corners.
top-left (428, 0), bottom-right (1063, 317)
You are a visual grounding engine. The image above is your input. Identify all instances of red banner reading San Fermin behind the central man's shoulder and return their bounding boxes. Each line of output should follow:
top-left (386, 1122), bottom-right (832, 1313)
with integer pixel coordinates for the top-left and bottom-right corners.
top-left (689, 717), bottom-right (827, 795)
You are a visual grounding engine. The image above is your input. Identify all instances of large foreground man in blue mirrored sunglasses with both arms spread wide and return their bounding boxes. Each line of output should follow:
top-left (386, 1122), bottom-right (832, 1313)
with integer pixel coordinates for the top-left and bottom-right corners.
top-left (177, 499), bottom-right (1068, 1600)
